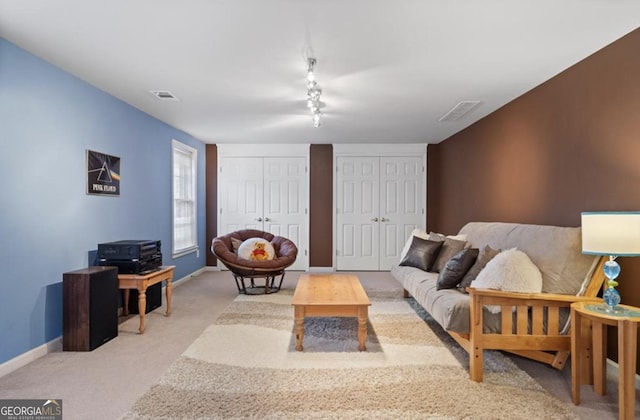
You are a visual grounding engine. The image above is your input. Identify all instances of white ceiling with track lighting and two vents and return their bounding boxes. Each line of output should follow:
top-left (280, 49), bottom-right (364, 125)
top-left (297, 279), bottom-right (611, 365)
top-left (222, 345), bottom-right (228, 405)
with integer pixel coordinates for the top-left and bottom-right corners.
top-left (0, 0), bottom-right (640, 144)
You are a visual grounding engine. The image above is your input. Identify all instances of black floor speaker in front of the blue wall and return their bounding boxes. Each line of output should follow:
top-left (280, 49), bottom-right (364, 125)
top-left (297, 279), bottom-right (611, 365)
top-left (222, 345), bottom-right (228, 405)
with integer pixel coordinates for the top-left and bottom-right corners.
top-left (62, 267), bottom-right (119, 351)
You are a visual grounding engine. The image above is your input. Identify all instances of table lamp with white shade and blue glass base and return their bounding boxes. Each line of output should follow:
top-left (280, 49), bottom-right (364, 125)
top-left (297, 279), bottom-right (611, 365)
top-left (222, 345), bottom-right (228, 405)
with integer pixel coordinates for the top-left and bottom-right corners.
top-left (582, 211), bottom-right (640, 313)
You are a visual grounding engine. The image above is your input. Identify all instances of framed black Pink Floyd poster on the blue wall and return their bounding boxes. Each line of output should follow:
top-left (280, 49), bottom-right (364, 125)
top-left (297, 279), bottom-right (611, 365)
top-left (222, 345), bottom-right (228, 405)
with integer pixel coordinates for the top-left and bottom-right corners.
top-left (87, 150), bottom-right (120, 196)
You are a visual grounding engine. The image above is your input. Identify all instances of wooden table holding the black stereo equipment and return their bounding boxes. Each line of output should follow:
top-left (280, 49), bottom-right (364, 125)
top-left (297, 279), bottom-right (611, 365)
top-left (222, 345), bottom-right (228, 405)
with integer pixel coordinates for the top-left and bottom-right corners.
top-left (118, 265), bottom-right (175, 334)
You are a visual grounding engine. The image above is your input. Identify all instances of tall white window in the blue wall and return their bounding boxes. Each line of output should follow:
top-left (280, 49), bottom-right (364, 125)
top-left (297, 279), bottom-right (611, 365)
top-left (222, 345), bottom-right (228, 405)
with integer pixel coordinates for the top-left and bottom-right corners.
top-left (172, 140), bottom-right (198, 257)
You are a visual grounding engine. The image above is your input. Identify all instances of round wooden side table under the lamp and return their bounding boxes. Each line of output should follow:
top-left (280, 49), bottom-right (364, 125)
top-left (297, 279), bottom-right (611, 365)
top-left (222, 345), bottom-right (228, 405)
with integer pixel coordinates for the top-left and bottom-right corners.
top-left (571, 302), bottom-right (640, 420)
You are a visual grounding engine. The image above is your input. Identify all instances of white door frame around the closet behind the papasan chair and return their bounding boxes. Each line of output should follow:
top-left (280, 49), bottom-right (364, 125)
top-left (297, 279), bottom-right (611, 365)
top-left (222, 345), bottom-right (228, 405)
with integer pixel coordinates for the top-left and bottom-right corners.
top-left (216, 143), bottom-right (311, 271)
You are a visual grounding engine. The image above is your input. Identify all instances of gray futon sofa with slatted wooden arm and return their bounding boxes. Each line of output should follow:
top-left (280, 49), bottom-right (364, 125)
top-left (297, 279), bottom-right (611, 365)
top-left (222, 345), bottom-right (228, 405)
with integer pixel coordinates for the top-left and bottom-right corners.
top-left (391, 222), bottom-right (603, 381)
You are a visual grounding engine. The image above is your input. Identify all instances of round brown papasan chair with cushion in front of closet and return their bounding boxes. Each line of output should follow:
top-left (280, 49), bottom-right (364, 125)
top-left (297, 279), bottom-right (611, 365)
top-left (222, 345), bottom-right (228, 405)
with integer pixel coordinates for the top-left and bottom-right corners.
top-left (211, 229), bottom-right (298, 295)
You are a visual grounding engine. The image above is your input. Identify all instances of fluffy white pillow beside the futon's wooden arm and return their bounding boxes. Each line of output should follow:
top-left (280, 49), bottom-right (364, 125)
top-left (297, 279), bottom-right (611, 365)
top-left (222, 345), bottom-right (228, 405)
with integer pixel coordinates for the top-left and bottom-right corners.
top-left (471, 248), bottom-right (542, 313)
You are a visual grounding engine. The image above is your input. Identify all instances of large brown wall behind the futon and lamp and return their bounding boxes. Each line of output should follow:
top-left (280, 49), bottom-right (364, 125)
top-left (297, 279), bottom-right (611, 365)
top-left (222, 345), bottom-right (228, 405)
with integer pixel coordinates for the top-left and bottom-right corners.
top-left (428, 29), bottom-right (640, 366)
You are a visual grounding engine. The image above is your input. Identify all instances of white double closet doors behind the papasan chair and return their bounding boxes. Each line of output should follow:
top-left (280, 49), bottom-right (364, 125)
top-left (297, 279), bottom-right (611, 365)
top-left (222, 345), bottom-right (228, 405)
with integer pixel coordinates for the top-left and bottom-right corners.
top-left (218, 157), bottom-right (308, 270)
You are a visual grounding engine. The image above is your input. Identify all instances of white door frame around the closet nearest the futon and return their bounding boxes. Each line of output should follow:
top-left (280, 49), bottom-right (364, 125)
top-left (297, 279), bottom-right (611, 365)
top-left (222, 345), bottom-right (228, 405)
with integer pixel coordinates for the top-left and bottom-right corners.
top-left (331, 143), bottom-right (427, 271)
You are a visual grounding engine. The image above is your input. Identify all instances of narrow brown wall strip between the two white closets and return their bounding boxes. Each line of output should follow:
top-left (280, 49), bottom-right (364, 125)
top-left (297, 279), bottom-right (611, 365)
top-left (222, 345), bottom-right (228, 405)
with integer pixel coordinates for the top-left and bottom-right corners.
top-left (309, 144), bottom-right (334, 267)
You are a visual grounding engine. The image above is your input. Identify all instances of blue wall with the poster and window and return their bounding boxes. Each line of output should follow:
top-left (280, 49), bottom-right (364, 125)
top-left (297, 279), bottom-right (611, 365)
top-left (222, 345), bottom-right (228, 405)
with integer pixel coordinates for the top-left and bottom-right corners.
top-left (0, 38), bottom-right (206, 364)
